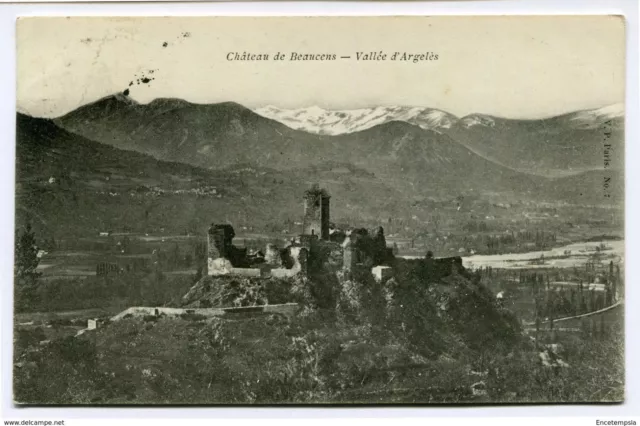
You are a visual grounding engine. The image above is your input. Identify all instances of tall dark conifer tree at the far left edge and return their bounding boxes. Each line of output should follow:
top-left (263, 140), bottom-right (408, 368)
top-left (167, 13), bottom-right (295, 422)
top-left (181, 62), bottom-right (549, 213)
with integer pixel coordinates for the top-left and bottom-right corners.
top-left (14, 224), bottom-right (40, 310)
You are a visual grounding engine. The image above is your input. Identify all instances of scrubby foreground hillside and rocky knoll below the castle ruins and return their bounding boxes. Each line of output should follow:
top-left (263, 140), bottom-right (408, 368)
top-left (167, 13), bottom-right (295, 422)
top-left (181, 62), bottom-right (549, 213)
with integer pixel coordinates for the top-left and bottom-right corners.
top-left (14, 261), bottom-right (623, 404)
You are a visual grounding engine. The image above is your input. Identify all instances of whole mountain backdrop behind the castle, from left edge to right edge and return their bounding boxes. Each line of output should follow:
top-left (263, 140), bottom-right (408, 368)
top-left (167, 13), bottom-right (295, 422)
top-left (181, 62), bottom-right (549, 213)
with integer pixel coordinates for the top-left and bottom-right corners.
top-left (16, 94), bottom-right (624, 236)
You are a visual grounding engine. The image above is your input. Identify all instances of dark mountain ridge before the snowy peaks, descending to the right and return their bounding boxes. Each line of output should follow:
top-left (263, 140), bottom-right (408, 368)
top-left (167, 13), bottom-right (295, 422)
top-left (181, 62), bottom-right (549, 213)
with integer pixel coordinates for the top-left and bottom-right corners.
top-left (55, 98), bottom-right (552, 196)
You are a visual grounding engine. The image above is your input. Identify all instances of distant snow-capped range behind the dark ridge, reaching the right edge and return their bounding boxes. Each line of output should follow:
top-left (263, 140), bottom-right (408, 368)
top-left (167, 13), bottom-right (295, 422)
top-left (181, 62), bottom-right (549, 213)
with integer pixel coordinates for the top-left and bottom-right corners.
top-left (255, 104), bottom-right (624, 176)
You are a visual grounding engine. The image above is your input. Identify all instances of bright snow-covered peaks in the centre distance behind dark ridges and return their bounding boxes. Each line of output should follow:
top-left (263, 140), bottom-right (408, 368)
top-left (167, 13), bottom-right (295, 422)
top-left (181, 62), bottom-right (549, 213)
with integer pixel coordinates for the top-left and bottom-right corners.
top-left (254, 105), bottom-right (458, 135)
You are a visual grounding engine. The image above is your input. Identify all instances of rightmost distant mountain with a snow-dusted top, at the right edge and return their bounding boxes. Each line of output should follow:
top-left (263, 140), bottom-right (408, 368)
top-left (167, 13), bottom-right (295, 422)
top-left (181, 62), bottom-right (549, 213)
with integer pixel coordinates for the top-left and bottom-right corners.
top-left (446, 104), bottom-right (624, 176)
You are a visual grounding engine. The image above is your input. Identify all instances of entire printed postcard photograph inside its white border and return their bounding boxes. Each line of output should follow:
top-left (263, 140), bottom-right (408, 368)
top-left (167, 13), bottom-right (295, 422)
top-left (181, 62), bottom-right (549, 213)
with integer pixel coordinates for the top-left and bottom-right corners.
top-left (14, 16), bottom-right (625, 404)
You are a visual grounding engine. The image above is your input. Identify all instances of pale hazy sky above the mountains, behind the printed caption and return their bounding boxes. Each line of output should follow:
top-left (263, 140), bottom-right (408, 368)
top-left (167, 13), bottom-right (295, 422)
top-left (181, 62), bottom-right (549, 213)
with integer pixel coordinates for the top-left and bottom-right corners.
top-left (17, 16), bottom-right (625, 118)
